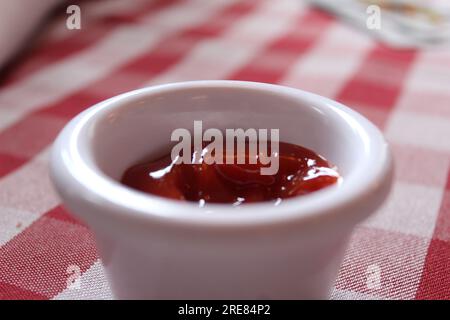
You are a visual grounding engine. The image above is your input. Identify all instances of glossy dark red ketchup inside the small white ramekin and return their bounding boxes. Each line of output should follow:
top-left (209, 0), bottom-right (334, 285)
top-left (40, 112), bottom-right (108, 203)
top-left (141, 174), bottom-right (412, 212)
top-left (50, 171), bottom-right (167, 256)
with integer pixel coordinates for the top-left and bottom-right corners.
top-left (121, 121), bottom-right (340, 206)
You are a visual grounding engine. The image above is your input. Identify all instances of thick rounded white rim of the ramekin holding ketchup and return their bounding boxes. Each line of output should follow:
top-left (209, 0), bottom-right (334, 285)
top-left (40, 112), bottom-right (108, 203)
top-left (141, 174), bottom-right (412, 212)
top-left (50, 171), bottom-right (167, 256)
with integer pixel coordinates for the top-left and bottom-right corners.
top-left (51, 80), bottom-right (392, 227)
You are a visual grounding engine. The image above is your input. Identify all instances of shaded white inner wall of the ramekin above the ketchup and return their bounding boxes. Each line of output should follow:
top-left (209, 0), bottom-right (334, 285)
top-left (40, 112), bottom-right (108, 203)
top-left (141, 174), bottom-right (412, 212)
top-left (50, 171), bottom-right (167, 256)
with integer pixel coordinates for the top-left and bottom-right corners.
top-left (91, 88), bottom-right (363, 183)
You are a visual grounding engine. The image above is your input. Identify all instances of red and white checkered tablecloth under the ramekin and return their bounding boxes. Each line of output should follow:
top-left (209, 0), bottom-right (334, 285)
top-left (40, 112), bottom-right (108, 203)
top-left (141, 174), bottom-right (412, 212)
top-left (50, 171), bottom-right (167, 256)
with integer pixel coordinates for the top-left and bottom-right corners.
top-left (0, 0), bottom-right (450, 299)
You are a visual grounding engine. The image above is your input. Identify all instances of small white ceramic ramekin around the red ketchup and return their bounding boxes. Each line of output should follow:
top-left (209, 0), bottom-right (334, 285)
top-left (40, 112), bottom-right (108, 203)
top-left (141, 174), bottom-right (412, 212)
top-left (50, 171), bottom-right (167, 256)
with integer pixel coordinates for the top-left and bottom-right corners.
top-left (51, 81), bottom-right (392, 299)
